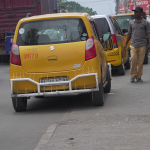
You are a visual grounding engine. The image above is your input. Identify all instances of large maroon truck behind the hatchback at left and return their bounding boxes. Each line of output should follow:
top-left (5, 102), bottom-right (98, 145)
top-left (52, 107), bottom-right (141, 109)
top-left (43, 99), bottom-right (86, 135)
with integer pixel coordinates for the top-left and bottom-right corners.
top-left (0, 0), bottom-right (58, 62)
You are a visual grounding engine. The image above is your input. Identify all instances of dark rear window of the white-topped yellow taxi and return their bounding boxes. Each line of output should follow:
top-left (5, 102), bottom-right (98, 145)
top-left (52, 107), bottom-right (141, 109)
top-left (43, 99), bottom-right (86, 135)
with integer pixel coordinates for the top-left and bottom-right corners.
top-left (94, 18), bottom-right (110, 38)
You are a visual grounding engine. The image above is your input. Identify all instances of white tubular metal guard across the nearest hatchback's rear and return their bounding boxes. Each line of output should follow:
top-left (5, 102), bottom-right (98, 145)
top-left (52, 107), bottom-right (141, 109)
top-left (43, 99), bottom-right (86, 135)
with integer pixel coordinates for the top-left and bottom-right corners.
top-left (10, 73), bottom-right (99, 97)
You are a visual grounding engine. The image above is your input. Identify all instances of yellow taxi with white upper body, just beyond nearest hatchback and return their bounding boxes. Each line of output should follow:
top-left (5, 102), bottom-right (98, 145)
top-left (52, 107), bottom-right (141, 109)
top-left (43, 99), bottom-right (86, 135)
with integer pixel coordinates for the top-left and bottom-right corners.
top-left (92, 15), bottom-right (130, 75)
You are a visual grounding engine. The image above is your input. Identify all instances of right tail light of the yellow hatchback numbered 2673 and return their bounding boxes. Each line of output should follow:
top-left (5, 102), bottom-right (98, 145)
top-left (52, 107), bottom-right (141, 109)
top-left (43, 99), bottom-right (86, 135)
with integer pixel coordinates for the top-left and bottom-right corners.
top-left (85, 37), bottom-right (96, 60)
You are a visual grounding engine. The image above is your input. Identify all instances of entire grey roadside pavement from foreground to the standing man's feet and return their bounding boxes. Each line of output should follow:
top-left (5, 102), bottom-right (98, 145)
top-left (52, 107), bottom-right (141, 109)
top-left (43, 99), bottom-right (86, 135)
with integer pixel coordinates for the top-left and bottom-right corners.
top-left (37, 59), bottom-right (150, 150)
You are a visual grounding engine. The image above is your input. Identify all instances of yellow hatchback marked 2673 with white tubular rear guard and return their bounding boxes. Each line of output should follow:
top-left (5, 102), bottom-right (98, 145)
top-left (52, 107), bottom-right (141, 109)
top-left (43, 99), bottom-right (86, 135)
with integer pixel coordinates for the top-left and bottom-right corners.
top-left (10, 13), bottom-right (111, 112)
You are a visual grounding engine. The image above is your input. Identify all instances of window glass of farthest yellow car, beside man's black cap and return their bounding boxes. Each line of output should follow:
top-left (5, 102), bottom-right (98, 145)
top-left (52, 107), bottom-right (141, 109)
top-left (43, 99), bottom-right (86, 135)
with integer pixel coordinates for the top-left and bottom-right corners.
top-left (114, 15), bottom-right (134, 29)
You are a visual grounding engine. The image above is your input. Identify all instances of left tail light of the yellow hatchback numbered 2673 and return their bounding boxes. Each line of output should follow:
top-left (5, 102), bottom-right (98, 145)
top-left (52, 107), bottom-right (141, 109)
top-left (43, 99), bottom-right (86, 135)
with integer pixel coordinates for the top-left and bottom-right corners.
top-left (10, 43), bottom-right (21, 66)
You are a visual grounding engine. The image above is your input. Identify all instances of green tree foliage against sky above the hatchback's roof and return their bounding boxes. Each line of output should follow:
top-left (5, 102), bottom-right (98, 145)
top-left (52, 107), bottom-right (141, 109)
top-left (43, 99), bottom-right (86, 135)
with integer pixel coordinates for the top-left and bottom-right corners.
top-left (60, 0), bottom-right (97, 15)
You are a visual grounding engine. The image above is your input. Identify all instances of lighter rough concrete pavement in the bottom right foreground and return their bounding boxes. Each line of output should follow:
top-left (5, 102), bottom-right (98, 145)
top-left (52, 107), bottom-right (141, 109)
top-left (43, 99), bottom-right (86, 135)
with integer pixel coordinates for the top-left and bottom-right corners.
top-left (44, 115), bottom-right (150, 150)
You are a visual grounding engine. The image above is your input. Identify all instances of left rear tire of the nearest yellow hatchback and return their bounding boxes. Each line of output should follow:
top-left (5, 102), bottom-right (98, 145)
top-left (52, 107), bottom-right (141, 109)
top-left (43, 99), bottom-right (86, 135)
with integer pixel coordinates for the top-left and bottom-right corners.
top-left (12, 97), bottom-right (27, 112)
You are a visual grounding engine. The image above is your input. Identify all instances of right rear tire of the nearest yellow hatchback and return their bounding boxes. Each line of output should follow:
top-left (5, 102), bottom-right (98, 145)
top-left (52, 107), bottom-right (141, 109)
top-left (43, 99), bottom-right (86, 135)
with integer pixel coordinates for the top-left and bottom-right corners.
top-left (92, 79), bottom-right (104, 106)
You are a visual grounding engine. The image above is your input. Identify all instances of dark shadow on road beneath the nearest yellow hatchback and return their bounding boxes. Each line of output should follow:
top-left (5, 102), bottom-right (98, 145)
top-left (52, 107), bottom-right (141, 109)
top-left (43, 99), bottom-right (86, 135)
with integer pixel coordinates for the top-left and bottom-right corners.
top-left (27, 94), bottom-right (107, 113)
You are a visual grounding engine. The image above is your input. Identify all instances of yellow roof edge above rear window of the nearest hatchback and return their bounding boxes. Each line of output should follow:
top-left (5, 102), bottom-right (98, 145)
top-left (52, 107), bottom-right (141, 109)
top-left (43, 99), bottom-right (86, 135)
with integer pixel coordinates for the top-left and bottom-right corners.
top-left (21, 13), bottom-right (92, 21)
